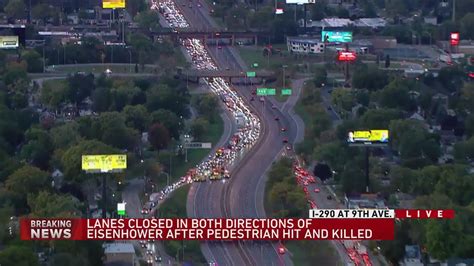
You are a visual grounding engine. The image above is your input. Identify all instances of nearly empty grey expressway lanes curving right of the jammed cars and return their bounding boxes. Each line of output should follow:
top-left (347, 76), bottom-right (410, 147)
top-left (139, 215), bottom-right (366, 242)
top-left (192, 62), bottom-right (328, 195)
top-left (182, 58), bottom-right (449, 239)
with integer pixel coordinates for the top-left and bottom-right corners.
top-left (170, 0), bottom-right (302, 265)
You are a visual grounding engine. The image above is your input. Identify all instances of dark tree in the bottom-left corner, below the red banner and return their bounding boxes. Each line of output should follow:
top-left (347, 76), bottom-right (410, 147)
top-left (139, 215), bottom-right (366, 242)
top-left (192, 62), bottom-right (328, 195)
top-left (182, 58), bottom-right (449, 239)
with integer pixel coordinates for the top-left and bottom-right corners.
top-left (0, 245), bottom-right (40, 266)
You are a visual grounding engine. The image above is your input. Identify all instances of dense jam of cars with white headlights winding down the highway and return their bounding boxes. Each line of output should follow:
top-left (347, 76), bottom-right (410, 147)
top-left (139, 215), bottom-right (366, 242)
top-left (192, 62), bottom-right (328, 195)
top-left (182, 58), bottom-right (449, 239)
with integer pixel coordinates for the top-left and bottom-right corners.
top-left (141, 0), bottom-right (261, 213)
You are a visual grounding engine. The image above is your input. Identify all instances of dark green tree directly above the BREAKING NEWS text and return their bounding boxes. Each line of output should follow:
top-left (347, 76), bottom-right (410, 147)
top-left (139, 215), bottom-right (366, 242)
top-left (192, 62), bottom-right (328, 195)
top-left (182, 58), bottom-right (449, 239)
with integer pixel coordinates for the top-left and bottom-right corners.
top-left (28, 191), bottom-right (81, 218)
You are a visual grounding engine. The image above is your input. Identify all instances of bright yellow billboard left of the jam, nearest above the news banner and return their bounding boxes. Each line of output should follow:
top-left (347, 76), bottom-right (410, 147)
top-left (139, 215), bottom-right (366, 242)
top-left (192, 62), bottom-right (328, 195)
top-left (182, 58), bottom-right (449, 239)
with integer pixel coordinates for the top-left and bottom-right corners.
top-left (82, 154), bottom-right (127, 172)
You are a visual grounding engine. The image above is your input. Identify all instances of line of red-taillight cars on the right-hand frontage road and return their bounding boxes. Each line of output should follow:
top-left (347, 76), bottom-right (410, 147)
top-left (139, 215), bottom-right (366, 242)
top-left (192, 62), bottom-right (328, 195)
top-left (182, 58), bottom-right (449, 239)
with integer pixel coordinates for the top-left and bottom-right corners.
top-left (293, 159), bottom-right (372, 266)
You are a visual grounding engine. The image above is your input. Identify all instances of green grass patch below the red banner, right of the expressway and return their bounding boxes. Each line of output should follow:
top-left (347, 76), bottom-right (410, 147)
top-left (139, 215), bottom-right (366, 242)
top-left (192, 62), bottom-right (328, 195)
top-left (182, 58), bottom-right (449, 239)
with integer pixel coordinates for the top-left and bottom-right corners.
top-left (285, 241), bottom-right (343, 266)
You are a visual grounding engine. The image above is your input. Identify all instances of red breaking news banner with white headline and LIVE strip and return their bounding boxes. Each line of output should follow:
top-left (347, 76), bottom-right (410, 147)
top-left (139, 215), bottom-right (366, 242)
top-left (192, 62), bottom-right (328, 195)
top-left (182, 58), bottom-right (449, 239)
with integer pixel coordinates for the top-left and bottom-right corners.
top-left (20, 209), bottom-right (454, 240)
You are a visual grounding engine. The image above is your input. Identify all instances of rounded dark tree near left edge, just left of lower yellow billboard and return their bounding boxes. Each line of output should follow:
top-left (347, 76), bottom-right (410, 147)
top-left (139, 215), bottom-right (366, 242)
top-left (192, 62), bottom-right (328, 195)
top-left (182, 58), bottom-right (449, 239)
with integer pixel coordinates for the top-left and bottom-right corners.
top-left (5, 165), bottom-right (50, 197)
